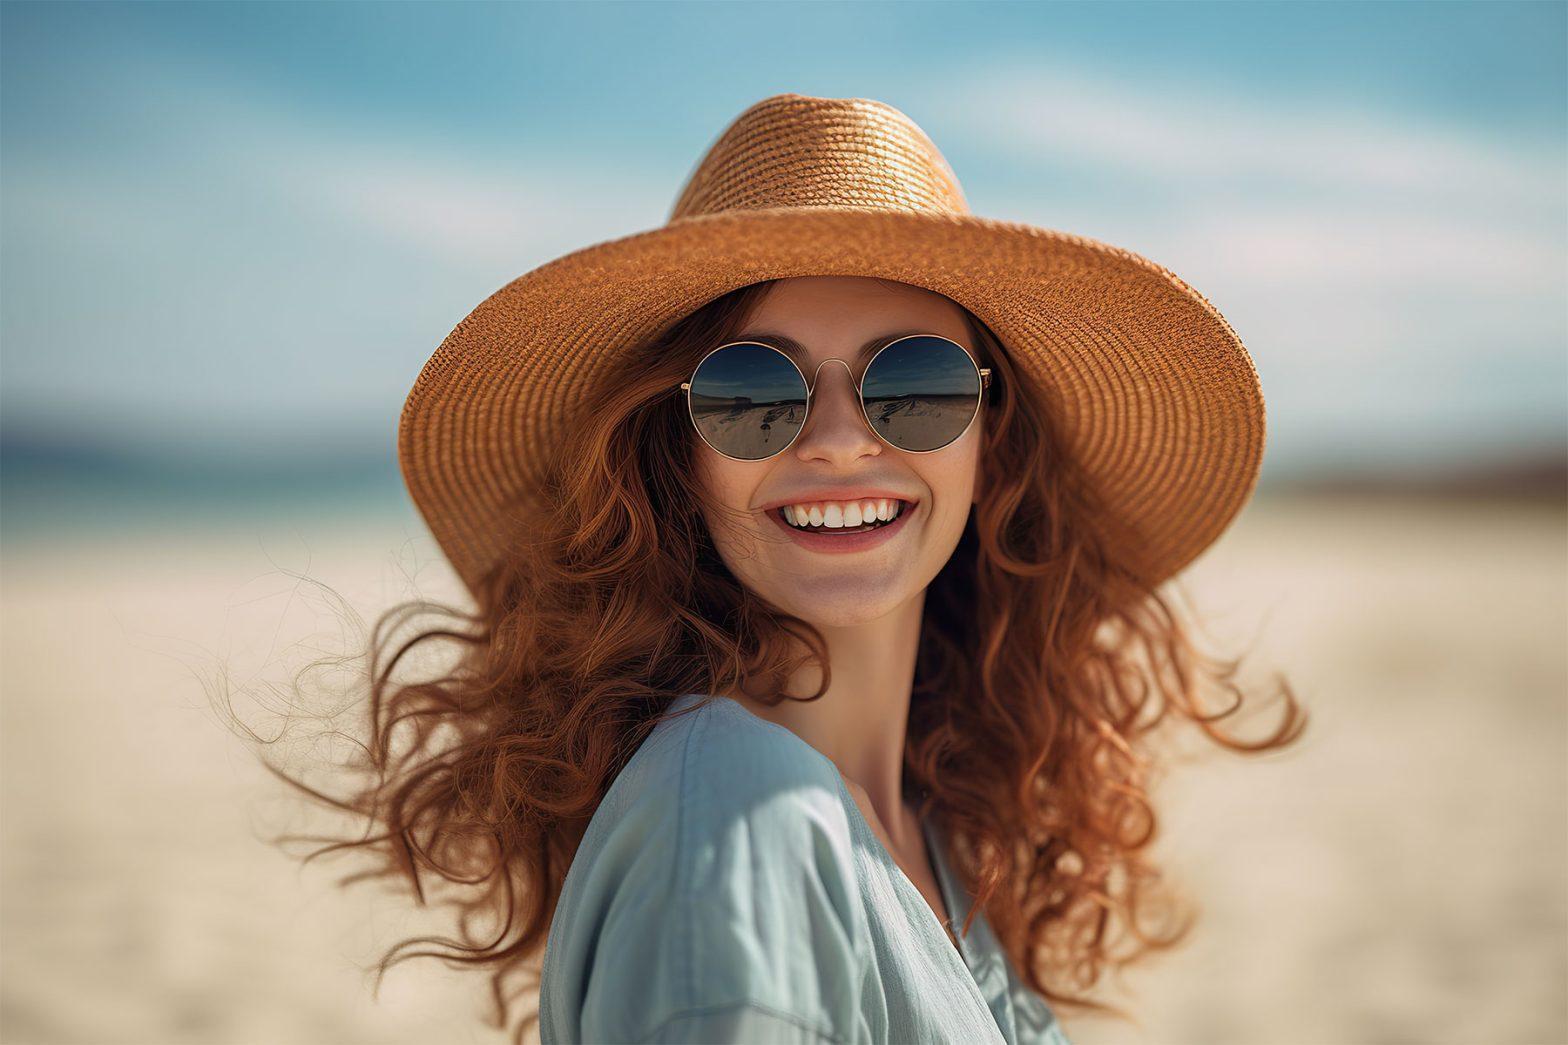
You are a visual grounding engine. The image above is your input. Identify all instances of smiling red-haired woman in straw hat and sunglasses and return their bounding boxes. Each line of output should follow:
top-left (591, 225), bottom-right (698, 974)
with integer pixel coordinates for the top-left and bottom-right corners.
top-left (263, 94), bottom-right (1305, 1045)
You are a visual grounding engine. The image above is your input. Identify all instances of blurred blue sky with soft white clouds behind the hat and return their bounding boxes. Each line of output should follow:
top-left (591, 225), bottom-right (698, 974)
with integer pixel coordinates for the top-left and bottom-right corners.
top-left (0, 3), bottom-right (1568, 475)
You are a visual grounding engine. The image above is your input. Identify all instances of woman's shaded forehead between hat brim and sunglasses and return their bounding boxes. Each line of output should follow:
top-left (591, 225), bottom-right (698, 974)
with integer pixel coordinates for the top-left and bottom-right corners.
top-left (739, 276), bottom-right (972, 358)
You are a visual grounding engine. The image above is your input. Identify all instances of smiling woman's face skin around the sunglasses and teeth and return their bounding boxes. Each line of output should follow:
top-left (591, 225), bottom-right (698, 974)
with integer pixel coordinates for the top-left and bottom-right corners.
top-left (691, 276), bottom-right (985, 628)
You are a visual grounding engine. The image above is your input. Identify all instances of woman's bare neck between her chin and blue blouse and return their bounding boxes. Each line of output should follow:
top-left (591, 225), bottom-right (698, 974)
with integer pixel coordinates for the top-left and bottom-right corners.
top-left (731, 590), bottom-right (925, 844)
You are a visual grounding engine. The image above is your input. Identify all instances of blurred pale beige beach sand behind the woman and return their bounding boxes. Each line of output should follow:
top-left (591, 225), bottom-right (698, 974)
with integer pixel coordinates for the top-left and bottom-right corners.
top-left (0, 497), bottom-right (1568, 1045)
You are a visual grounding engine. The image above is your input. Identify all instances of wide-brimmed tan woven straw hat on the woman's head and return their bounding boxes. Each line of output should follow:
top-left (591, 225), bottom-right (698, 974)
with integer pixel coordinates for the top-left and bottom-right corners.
top-left (398, 94), bottom-right (1264, 611)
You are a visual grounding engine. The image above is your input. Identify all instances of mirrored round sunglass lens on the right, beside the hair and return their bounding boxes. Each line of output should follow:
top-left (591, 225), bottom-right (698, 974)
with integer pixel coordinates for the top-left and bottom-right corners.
top-left (861, 336), bottom-right (980, 450)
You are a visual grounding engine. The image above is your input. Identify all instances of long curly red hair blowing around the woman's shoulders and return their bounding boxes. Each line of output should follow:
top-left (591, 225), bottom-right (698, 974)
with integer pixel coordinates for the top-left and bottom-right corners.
top-left (235, 281), bottom-right (1306, 1042)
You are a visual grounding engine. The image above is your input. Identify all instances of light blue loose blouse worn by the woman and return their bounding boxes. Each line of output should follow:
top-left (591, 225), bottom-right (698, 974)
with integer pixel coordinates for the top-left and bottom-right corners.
top-left (539, 694), bottom-right (1068, 1045)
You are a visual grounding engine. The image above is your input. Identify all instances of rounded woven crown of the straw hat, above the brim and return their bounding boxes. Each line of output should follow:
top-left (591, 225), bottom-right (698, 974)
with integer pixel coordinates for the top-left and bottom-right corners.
top-left (670, 94), bottom-right (969, 221)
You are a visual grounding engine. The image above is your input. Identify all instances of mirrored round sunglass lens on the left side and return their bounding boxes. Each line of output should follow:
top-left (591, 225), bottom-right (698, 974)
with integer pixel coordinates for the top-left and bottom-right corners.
top-left (691, 342), bottom-right (806, 461)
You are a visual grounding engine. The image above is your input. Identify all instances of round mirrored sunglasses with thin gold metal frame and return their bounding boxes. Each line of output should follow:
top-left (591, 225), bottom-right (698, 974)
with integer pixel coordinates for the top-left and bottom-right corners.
top-left (681, 334), bottom-right (991, 461)
